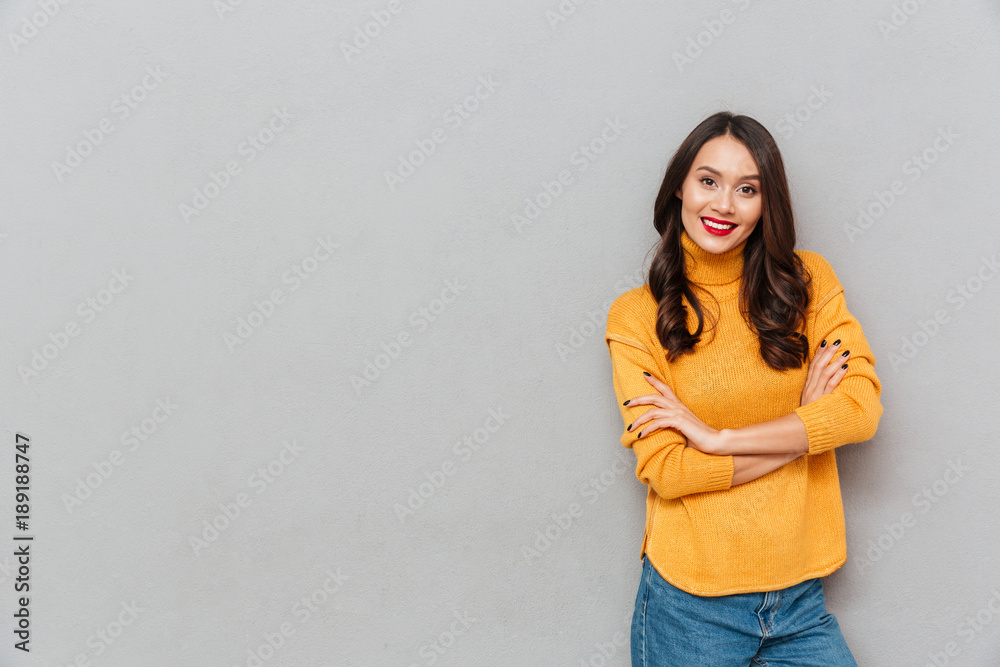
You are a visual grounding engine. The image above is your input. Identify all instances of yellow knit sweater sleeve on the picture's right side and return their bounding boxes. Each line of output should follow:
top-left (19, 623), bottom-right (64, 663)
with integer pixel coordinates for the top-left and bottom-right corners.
top-left (794, 259), bottom-right (882, 455)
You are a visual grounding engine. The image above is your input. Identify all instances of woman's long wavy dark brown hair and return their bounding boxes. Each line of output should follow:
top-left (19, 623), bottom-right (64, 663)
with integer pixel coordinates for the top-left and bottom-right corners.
top-left (649, 111), bottom-right (811, 371)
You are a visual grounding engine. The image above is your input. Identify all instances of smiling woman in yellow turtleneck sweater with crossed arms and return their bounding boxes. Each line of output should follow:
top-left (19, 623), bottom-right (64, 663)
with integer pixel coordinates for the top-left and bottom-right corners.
top-left (605, 112), bottom-right (882, 667)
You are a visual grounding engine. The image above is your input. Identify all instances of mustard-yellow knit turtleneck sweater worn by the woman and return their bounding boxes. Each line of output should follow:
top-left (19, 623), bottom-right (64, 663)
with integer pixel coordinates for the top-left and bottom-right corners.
top-left (605, 231), bottom-right (882, 596)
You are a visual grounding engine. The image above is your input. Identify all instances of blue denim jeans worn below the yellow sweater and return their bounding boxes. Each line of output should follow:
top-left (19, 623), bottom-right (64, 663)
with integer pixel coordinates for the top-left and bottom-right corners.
top-left (632, 556), bottom-right (858, 667)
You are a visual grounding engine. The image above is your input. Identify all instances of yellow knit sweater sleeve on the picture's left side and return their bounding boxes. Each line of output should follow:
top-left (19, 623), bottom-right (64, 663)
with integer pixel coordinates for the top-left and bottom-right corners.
top-left (605, 307), bottom-right (733, 499)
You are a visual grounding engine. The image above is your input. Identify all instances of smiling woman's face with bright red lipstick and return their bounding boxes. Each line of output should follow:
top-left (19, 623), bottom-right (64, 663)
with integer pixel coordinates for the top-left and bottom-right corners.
top-left (676, 135), bottom-right (763, 254)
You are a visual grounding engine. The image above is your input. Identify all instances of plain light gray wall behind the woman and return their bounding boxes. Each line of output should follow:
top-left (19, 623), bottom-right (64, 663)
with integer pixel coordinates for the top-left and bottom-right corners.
top-left (0, 0), bottom-right (1000, 667)
